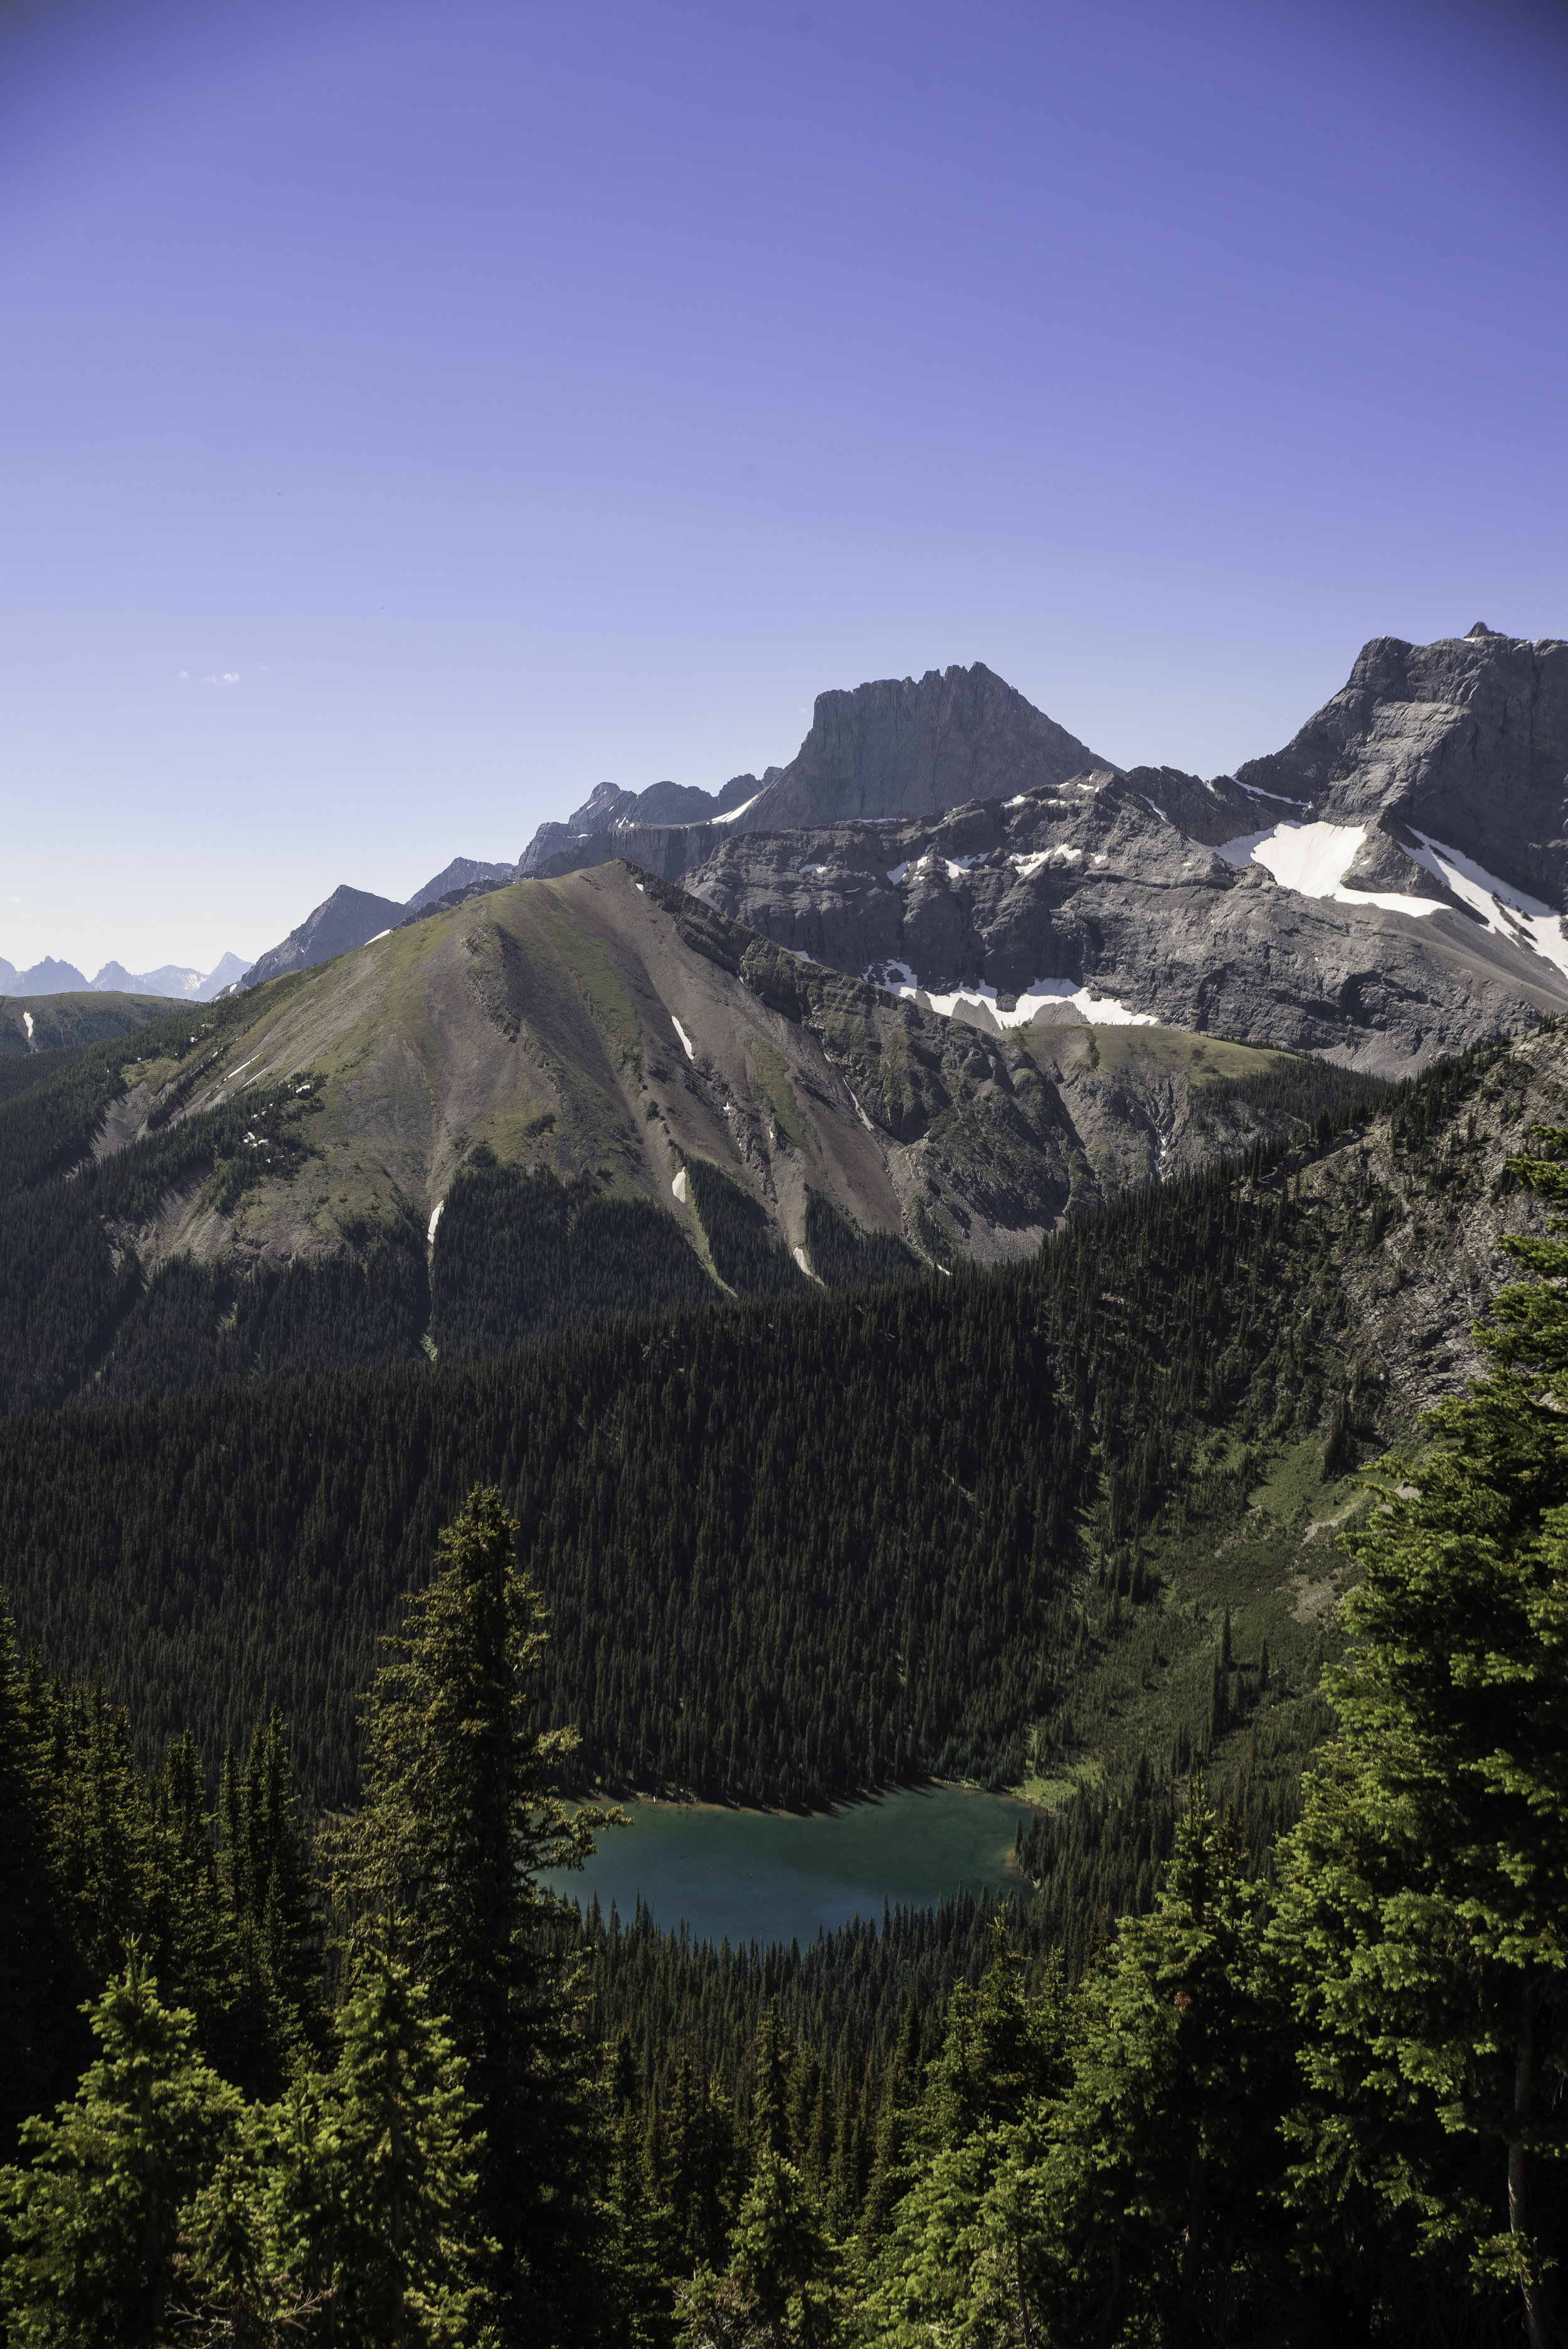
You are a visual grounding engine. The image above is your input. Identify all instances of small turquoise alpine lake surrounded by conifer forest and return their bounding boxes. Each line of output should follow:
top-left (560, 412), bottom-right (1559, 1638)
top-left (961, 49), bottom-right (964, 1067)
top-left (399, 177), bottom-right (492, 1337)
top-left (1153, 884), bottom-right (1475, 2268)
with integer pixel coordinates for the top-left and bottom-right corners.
top-left (547, 1785), bottom-right (1033, 1945)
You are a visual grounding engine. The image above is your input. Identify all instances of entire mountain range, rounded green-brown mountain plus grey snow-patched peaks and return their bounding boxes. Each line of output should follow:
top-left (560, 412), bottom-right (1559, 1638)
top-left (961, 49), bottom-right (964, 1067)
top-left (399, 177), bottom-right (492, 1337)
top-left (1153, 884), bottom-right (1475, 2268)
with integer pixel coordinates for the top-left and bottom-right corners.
top-left (0, 630), bottom-right (1568, 1409)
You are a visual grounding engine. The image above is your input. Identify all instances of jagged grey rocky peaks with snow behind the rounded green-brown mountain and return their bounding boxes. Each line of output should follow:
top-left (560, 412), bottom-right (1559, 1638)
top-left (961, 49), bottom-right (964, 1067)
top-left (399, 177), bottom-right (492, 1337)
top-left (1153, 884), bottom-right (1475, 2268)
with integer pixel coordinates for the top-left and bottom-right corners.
top-left (232, 625), bottom-right (1568, 1073)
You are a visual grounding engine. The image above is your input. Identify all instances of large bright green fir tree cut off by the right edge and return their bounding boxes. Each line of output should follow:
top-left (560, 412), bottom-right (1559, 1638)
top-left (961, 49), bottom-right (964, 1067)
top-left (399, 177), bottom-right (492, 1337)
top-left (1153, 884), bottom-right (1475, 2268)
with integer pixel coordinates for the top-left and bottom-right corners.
top-left (1277, 1128), bottom-right (1568, 2349)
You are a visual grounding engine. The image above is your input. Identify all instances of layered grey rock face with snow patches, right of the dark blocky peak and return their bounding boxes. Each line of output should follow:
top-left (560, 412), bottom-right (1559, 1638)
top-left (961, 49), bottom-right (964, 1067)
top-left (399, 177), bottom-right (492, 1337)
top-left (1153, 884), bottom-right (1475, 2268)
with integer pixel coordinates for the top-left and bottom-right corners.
top-left (688, 634), bottom-right (1568, 1073)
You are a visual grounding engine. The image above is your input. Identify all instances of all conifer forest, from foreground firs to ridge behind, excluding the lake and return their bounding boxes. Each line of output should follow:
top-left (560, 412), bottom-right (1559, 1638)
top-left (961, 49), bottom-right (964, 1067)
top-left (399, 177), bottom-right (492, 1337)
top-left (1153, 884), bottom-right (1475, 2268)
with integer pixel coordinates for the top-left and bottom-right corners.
top-left (0, 1019), bottom-right (1568, 2349)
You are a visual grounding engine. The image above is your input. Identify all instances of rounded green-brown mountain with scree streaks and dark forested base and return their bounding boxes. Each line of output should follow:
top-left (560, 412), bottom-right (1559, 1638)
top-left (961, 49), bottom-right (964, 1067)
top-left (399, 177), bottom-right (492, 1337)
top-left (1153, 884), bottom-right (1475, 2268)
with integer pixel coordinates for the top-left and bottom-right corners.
top-left (0, 864), bottom-right (1375, 1409)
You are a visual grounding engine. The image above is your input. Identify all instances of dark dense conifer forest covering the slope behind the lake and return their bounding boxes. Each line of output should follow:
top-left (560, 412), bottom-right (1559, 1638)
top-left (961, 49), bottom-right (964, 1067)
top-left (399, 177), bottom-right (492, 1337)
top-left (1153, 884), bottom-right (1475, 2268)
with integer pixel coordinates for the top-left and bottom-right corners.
top-left (0, 1066), bottom-right (1399, 1801)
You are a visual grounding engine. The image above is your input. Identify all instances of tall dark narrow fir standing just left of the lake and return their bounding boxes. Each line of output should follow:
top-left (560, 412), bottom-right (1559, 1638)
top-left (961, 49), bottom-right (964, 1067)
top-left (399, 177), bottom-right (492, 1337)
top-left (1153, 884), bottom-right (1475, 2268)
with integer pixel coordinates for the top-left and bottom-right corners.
top-left (331, 1487), bottom-right (613, 2342)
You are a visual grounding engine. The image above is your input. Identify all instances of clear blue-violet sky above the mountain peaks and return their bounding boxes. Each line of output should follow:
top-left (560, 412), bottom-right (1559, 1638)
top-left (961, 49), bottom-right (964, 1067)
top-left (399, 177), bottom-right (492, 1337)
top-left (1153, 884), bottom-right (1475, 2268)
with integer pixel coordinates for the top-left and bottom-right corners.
top-left (0, 0), bottom-right (1568, 972)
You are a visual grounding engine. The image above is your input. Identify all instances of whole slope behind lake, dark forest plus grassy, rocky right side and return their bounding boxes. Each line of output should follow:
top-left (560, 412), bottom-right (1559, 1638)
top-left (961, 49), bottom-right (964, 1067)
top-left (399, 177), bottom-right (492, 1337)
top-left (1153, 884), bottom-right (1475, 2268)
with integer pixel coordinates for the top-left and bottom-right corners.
top-left (0, 1029), bottom-right (1565, 1801)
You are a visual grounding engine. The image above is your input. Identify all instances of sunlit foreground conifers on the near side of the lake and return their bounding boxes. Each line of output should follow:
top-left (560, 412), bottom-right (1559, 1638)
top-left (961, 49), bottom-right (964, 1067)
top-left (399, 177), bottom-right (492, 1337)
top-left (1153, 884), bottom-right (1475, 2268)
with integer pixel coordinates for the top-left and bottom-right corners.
top-left (0, 1108), bottom-right (1568, 2349)
